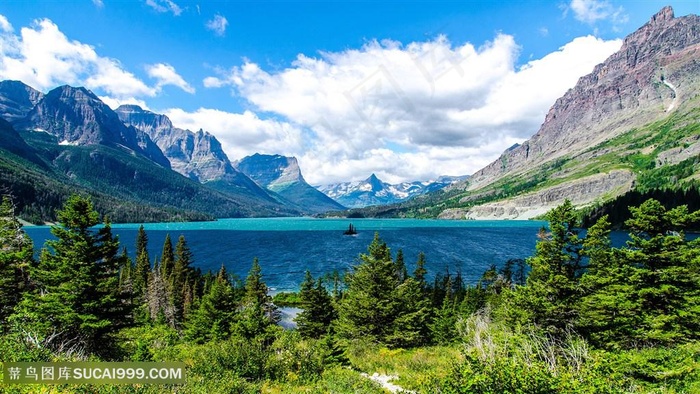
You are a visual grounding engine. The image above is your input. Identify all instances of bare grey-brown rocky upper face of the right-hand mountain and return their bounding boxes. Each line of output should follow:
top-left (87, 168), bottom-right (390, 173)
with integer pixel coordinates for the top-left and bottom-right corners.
top-left (469, 7), bottom-right (700, 190)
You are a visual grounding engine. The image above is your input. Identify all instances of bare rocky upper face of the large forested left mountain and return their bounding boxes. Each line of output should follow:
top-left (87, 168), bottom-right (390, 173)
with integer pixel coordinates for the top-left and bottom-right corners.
top-left (13, 86), bottom-right (170, 168)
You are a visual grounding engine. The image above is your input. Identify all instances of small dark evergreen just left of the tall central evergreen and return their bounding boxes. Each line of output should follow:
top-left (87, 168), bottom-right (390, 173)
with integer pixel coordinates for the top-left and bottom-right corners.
top-left (295, 270), bottom-right (336, 338)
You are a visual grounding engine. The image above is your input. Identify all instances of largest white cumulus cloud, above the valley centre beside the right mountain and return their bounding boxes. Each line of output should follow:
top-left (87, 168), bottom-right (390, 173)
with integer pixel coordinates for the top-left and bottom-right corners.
top-left (204, 34), bottom-right (621, 183)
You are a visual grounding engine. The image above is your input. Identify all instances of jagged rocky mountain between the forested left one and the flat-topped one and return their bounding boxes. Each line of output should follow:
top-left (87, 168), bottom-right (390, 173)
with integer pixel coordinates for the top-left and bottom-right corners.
top-left (115, 105), bottom-right (280, 205)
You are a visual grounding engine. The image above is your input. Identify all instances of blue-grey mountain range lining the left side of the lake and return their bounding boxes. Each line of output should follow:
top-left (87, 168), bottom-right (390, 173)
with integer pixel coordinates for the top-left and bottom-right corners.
top-left (0, 81), bottom-right (448, 222)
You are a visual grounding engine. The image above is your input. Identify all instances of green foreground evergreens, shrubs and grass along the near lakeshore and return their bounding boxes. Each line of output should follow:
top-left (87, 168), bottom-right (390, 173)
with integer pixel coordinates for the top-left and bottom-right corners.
top-left (0, 196), bottom-right (700, 393)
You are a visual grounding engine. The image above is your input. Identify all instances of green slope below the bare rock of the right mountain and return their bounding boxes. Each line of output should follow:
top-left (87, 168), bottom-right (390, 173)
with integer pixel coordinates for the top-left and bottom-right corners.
top-left (351, 97), bottom-right (700, 222)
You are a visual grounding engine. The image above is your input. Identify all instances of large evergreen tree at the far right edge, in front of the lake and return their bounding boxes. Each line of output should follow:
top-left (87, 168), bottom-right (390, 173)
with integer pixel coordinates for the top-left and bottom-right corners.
top-left (622, 199), bottom-right (700, 344)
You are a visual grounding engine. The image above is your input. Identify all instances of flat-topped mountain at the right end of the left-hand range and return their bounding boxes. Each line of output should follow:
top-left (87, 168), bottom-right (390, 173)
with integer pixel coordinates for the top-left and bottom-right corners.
top-left (235, 153), bottom-right (345, 214)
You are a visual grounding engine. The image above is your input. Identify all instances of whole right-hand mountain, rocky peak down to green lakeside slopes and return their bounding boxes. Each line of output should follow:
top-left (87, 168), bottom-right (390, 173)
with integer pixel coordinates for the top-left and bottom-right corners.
top-left (344, 7), bottom-right (700, 219)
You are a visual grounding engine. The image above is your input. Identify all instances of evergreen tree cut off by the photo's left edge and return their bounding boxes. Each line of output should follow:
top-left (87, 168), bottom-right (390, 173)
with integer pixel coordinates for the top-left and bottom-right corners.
top-left (0, 196), bottom-right (34, 333)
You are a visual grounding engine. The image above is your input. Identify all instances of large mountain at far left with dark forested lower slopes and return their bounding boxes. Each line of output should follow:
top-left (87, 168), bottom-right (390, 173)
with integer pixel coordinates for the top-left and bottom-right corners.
top-left (0, 83), bottom-right (297, 222)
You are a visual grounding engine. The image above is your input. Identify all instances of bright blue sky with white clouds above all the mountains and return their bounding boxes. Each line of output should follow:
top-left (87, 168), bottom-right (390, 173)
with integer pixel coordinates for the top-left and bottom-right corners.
top-left (0, 0), bottom-right (700, 184)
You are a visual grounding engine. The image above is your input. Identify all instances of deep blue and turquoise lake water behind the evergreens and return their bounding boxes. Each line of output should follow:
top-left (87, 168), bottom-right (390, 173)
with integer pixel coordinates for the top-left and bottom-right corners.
top-left (24, 218), bottom-right (546, 291)
